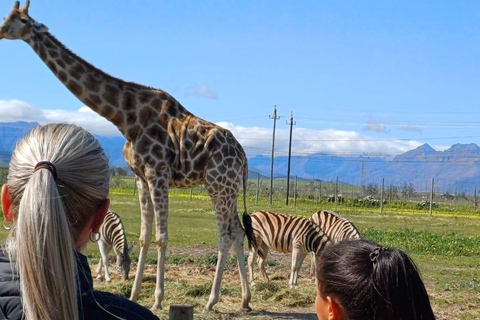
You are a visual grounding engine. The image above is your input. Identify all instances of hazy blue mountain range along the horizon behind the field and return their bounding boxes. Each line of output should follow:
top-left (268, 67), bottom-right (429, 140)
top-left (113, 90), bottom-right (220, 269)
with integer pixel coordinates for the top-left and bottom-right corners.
top-left (0, 122), bottom-right (480, 194)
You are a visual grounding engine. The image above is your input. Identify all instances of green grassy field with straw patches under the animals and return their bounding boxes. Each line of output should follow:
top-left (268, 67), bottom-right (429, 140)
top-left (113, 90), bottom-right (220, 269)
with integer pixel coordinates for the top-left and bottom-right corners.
top-left (0, 190), bottom-right (480, 320)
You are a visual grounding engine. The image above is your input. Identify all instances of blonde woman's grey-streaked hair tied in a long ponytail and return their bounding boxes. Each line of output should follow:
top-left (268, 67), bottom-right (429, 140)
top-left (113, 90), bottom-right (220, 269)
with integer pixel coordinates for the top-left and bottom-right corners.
top-left (6, 124), bottom-right (109, 320)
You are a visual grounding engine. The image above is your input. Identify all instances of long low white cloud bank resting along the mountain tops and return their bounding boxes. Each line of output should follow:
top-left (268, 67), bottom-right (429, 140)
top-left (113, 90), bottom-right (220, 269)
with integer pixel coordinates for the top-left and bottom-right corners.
top-left (0, 100), bottom-right (422, 156)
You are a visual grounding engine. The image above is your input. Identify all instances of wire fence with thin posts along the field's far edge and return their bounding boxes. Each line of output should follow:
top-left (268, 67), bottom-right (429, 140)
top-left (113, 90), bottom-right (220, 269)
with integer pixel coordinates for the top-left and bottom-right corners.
top-left (0, 168), bottom-right (479, 214)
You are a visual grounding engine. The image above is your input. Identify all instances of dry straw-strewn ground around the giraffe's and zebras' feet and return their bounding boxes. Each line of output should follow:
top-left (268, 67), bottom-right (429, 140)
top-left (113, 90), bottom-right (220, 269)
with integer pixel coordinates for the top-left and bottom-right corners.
top-left (92, 247), bottom-right (454, 320)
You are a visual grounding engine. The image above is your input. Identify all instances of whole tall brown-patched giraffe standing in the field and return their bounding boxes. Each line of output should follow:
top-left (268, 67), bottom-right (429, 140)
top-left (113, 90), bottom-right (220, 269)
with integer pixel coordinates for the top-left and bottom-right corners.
top-left (0, 1), bottom-right (253, 312)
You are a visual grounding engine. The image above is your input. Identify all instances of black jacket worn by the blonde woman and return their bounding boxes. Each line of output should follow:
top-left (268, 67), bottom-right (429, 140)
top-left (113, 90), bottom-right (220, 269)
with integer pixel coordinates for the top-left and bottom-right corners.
top-left (0, 248), bottom-right (158, 320)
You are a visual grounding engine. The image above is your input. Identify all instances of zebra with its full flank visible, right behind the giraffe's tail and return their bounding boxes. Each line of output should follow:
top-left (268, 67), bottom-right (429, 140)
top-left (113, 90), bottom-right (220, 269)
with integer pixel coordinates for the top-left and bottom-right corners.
top-left (248, 211), bottom-right (330, 288)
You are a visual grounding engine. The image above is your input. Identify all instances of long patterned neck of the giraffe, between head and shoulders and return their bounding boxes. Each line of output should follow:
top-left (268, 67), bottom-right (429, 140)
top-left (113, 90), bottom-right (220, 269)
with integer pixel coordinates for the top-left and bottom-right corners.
top-left (25, 32), bottom-right (166, 139)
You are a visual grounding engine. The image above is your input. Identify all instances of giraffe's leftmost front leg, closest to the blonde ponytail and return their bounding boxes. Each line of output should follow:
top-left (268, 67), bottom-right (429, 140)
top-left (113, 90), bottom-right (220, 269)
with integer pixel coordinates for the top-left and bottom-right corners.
top-left (130, 177), bottom-right (153, 301)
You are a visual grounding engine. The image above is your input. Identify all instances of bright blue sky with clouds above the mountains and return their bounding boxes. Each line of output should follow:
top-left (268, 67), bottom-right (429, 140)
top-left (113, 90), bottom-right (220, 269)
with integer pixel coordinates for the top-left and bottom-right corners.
top-left (0, 0), bottom-right (480, 156)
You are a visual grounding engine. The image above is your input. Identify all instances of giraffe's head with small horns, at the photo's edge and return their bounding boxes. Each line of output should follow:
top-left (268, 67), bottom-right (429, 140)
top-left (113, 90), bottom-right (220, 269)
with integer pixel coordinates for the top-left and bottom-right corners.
top-left (0, 0), bottom-right (48, 40)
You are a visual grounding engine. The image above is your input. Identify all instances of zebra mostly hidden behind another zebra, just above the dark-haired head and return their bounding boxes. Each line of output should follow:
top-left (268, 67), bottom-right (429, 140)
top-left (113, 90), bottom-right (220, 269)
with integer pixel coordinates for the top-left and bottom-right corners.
top-left (310, 210), bottom-right (360, 276)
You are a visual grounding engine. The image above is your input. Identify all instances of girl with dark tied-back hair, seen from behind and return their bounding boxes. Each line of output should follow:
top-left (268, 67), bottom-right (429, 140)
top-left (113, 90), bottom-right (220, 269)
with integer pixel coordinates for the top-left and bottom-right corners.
top-left (315, 239), bottom-right (435, 320)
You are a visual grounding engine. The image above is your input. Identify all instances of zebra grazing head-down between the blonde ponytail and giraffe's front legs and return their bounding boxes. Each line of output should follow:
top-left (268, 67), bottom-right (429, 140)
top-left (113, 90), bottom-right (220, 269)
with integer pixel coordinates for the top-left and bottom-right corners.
top-left (97, 210), bottom-right (133, 282)
